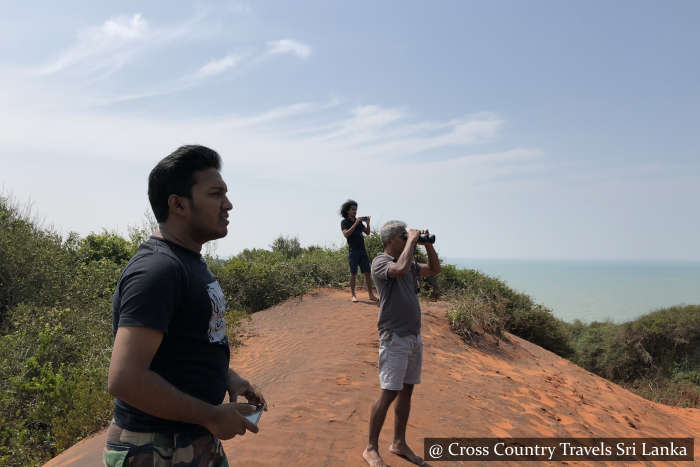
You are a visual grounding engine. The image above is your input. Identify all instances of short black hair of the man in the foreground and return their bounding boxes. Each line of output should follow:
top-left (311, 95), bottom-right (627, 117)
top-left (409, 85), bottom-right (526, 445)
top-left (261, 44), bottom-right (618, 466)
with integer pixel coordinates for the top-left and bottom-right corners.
top-left (148, 145), bottom-right (221, 222)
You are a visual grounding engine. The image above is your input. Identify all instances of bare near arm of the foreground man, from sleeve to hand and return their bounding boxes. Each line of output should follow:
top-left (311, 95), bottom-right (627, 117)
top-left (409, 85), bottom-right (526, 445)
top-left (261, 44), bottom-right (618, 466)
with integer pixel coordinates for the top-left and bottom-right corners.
top-left (107, 326), bottom-right (258, 439)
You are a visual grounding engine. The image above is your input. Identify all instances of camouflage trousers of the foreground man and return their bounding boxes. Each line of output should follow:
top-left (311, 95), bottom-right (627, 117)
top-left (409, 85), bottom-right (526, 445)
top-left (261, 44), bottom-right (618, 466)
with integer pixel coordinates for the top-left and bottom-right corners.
top-left (103, 422), bottom-right (228, 467)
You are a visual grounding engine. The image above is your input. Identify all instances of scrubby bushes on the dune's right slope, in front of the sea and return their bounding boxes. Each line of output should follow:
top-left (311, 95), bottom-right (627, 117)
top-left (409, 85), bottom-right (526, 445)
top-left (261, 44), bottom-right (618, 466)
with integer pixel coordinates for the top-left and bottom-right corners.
top-left (446, 265), bottom-right (700, 407)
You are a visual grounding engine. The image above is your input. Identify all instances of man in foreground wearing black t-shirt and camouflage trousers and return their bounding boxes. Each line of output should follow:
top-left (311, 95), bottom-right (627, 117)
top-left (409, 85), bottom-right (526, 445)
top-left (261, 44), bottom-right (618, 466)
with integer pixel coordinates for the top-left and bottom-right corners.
top-left (104, 146), bottom-right (265, 466)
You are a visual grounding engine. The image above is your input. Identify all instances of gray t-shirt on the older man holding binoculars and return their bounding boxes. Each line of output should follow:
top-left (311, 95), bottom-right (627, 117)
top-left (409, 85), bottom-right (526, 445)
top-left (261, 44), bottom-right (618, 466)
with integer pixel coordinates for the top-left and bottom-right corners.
top-left (372, 252), bottom-right (420, 337)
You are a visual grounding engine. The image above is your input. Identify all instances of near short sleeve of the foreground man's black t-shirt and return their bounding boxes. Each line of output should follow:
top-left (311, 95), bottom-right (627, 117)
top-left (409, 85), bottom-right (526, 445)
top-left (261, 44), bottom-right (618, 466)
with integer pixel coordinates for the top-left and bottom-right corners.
top-left (118, 254), bottom-right (184, 333)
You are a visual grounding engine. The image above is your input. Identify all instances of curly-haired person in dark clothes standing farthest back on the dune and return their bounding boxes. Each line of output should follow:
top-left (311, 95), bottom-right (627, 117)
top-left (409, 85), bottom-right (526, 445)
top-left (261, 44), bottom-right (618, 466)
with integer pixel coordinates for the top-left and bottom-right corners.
top-left (340, 199), bottom-right (377, 302)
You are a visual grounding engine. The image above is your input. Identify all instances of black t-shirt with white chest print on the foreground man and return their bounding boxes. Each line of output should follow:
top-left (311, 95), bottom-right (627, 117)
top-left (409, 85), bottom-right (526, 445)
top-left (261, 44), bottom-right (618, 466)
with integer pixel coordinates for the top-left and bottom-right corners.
top-left (112, 237), bottom-right (230, 433)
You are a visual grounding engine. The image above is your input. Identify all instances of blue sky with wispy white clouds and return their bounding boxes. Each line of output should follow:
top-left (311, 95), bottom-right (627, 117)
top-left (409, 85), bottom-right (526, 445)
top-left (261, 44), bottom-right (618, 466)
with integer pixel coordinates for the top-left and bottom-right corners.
top-left (0, 1), bottom-right (700, 260)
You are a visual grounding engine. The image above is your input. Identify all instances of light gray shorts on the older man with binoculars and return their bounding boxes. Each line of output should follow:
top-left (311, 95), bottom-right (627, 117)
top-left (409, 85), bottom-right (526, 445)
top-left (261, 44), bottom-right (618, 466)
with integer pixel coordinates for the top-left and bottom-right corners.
top-left (379, 331), bottom-right (423, 391)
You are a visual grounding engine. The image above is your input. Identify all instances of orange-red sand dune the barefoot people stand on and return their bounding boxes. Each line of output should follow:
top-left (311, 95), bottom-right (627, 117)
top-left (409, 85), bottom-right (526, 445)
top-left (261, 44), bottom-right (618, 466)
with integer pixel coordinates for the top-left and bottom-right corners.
top-left (47, 289), bottom-right (700, 466)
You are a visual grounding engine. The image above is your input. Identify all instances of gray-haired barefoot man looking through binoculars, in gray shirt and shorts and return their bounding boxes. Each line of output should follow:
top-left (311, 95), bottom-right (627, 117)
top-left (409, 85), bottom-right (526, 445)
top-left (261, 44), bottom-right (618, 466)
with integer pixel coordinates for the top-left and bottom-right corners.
top-left (362, 221), bottom-right (440, 467)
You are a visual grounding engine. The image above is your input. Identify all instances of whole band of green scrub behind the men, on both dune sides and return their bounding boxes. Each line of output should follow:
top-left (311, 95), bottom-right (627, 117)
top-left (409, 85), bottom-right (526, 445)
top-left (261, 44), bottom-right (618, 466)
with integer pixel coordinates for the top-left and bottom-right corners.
top-left (0, 198), bottom-right (700, 466)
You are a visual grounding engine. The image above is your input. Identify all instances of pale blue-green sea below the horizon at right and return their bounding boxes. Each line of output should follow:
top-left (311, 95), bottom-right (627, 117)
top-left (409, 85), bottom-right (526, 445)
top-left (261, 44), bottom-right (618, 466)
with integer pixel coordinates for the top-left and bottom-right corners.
top-left (444, 258), bottom-right (700, 323)
